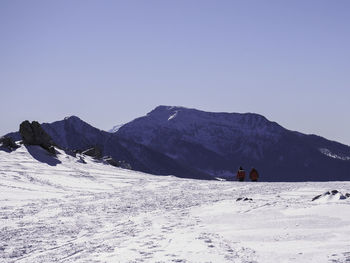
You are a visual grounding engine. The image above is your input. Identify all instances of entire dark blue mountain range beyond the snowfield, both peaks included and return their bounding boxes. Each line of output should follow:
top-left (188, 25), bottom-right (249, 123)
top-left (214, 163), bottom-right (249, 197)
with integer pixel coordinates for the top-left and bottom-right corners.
top-left (5, 106), bottom-right (350, 181)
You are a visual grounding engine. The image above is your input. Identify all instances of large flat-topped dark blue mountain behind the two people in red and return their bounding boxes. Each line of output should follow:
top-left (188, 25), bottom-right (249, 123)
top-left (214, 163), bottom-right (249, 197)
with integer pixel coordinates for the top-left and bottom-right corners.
top-left (116, 106), bottom-right (350, 181)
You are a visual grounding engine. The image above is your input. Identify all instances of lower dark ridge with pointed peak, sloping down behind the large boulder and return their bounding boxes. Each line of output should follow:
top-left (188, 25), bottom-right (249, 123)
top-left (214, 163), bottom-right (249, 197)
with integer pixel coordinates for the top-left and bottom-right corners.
top-left (7, 116), bottom-right (214, 179)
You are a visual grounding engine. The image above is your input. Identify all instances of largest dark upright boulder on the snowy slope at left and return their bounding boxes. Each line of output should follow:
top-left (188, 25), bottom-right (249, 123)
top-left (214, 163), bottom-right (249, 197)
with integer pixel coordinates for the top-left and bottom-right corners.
top-left (19, 121), bottom-right (56, 154)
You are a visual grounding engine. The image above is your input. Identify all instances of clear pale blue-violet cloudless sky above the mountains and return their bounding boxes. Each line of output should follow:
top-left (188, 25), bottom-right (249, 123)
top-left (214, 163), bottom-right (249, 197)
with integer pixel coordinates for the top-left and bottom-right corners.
top-left (0, 0), bottom-right (350, 145)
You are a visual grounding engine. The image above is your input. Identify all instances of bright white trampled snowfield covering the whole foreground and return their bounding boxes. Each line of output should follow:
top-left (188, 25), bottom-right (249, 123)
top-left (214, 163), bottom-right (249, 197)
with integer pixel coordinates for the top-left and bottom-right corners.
top-left (0, 146), bottom-right (350, 263)
